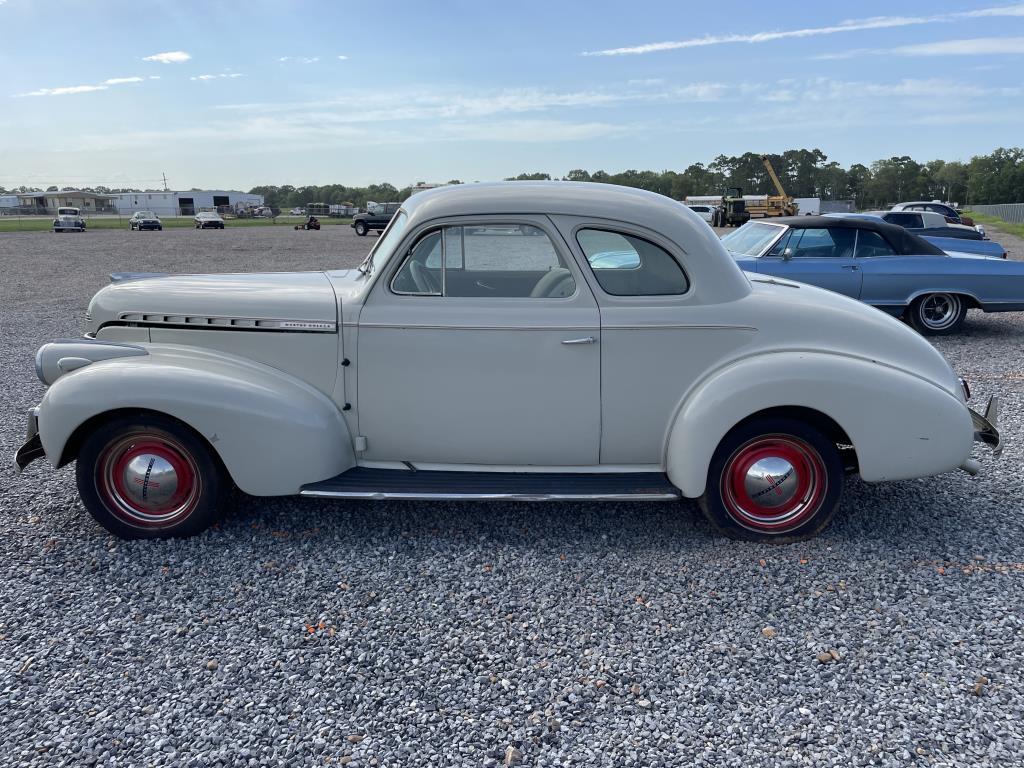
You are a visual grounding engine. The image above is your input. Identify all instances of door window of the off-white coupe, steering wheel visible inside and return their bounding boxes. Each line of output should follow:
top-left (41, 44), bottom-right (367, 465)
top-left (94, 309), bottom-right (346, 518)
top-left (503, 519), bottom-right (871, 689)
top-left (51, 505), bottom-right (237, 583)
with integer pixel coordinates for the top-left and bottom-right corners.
top-left (391, 224), bottom-right (575, 299)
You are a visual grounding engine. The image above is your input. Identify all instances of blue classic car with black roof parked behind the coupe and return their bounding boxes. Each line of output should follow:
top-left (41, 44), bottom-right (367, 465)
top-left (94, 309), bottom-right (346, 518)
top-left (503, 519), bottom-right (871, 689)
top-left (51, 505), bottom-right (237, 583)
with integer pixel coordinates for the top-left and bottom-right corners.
top-left (722, 216), bottom-right (1024, 335)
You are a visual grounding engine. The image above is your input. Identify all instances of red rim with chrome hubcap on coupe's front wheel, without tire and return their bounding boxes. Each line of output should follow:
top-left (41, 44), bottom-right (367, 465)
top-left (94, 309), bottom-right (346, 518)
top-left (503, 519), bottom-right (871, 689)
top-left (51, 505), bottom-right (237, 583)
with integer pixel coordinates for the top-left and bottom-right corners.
top-left (96, 432), bottom-right (202, 528)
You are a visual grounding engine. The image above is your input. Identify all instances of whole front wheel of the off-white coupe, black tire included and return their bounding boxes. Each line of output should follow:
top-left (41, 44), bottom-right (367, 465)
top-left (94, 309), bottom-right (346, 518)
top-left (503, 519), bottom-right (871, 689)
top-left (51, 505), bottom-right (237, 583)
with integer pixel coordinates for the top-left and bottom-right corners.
top-left (75, 412), bottom-right (232, 539)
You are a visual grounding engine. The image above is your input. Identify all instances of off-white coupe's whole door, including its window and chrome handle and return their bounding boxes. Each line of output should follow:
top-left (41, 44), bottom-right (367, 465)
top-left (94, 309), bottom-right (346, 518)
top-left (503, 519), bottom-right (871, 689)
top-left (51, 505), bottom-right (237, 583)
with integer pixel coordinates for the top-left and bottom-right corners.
top-left (356, 216), bottom-right (601, 467)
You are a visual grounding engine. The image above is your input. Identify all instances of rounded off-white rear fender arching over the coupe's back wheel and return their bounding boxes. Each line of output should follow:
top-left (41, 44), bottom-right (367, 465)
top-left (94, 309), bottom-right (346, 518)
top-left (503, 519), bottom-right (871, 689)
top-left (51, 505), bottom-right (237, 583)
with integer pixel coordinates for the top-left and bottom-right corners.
top-left (666, 351), bottom-right (974, 498)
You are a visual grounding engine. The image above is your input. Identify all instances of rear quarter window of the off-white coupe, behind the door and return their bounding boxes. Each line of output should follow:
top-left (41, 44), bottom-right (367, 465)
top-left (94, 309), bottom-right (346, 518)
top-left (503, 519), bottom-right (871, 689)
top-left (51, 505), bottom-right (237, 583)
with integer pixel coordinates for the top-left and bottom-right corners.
top-left (577, 229), bottom-right (689, 296)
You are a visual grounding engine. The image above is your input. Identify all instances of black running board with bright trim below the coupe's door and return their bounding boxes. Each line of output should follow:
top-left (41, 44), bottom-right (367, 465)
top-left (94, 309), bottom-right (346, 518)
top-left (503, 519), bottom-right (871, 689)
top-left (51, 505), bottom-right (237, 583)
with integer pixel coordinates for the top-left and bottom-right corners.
top-left (299, 467), bottom-right (681, 502)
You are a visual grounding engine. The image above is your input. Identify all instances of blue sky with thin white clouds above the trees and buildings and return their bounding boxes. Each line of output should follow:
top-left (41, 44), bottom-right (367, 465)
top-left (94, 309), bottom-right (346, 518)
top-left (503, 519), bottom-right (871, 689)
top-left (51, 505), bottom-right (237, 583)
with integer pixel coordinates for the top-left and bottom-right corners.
top-left (0, 0), bottom-right (1024, 189)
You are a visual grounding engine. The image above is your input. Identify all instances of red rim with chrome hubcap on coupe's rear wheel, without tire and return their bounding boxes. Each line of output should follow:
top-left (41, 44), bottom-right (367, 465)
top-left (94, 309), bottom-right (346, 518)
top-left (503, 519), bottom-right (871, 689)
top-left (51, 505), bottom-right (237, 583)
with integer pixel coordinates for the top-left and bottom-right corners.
top-left (721, 435), bottom-right (828, 534)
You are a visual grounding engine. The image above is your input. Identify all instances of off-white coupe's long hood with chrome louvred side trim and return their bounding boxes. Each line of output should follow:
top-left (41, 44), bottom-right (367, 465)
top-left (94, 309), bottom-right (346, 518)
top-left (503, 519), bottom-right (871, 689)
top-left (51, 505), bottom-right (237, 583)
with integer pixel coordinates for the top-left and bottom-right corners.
top-left (86, 272), bottom-right (338, 333)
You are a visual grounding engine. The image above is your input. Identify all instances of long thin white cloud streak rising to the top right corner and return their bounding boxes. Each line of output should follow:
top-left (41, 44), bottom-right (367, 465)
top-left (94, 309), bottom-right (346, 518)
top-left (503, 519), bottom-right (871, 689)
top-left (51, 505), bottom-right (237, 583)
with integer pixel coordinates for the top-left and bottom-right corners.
top-left (583, 3), bottom-right (1024, 56)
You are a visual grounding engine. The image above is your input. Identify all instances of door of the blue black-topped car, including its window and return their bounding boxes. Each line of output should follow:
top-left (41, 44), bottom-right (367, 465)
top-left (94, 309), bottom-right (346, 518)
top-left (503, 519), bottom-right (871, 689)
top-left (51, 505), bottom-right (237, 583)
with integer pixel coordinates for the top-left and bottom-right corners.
top-left (758, 226), bottom-right (861, 298)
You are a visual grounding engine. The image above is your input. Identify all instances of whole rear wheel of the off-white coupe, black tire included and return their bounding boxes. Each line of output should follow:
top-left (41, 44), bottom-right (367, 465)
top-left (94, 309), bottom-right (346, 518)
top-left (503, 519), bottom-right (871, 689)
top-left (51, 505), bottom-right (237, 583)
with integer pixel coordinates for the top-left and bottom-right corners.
top-left (699, 417), bottom-right (845, 544)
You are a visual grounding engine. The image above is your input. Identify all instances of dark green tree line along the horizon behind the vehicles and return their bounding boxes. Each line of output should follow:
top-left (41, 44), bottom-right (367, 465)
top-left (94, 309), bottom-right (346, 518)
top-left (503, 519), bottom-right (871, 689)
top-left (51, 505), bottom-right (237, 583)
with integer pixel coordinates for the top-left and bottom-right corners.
top-left (0, 147), bottom-right (1024, 210)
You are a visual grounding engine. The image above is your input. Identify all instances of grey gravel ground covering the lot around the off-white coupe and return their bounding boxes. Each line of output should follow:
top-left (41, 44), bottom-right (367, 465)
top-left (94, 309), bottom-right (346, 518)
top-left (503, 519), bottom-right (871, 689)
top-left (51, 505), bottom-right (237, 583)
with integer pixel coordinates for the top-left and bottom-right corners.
top-left (0, 222), bottom-right (1024, 767)
